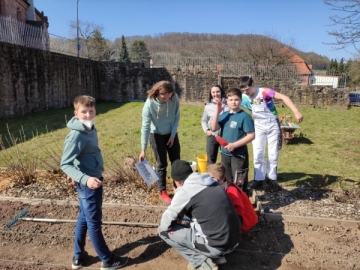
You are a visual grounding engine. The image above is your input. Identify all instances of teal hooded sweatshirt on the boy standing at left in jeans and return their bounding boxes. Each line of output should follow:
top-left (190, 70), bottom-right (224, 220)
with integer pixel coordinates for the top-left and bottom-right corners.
top-left (60, 117), bottom-right (104, 185)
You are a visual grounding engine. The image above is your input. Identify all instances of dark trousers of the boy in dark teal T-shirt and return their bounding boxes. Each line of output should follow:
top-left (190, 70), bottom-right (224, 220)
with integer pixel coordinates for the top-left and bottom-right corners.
top-left (221, 152), bottom-right (249, 191)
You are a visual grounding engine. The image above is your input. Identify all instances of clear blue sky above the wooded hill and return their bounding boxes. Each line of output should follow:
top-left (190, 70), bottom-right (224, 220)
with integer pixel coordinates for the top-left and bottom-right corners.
top-left (34, 0), bottom-right (354, 61)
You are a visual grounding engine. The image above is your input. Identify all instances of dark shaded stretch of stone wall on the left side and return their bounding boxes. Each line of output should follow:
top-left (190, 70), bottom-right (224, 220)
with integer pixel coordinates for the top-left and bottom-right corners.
top-left (0, 42), bottom-right (175, 117)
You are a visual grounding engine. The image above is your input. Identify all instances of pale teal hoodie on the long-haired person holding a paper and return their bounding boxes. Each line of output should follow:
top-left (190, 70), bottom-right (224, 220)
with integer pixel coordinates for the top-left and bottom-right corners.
top-left (141, 93), bottom-right (180, 150)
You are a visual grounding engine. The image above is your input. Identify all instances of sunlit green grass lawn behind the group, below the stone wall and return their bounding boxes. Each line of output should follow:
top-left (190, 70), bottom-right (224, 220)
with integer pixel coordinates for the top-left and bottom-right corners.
top-left (0, 102), bottom-right (360, 188)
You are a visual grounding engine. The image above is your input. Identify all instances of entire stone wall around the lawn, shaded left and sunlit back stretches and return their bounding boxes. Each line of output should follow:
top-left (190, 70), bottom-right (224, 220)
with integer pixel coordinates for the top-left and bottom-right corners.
top-left (0, 42), bottom-right (350, 117)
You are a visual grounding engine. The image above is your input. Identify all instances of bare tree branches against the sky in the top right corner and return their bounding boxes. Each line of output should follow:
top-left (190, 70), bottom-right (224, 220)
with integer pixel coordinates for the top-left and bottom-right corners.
top-left (324, 0), bottom-right (360, 52)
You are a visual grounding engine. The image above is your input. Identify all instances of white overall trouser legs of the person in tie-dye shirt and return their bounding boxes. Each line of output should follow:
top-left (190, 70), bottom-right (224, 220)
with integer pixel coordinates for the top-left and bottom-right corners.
top-left (252, 119), bottom-right (280, 181)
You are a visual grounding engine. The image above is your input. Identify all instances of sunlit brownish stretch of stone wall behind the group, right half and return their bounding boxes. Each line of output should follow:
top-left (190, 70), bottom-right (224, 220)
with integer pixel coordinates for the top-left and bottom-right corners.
top-left (168, 69), bottom-right (351, 108)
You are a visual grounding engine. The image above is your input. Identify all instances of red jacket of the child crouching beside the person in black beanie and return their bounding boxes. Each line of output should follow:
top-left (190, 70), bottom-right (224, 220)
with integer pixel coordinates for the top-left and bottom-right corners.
top-left (222, 180), bottom-right (258, 233)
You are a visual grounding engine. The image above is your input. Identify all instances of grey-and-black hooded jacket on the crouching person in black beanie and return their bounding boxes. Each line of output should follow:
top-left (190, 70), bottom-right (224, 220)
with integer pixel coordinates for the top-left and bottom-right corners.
top-left (159, 172), bottom-right (241, 250)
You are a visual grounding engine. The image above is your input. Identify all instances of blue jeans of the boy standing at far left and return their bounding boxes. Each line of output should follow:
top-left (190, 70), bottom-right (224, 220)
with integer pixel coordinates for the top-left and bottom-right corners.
top-left (74, 183), bottom-right (112, 262)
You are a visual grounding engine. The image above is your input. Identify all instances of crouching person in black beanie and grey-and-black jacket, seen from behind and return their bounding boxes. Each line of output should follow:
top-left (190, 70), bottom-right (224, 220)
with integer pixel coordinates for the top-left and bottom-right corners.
top-left (158, 159), bottom-right (241, 270)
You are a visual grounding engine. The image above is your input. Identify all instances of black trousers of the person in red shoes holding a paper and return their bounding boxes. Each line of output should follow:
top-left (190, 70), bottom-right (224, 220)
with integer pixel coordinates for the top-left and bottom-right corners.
top-left (150, 133), bottom-right (180, 191)
